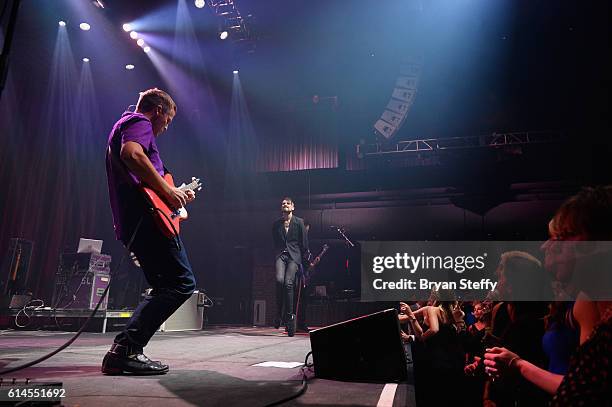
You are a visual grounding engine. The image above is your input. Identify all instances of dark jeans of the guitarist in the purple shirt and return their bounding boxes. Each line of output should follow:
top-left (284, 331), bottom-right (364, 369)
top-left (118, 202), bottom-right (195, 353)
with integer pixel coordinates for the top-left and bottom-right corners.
top-left (115, 214), bottom-right (195, 348)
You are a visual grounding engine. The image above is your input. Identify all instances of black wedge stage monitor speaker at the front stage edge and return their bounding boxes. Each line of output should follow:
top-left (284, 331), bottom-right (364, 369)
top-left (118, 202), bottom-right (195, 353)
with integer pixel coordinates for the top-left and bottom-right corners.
top-left (310, 309), bottom-right (407, 383)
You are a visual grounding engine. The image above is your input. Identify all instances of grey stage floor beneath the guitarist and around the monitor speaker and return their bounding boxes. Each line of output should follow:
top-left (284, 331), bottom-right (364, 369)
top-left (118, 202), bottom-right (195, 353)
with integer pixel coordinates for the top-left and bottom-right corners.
top-left (0, 327), bottom-right (415, 407)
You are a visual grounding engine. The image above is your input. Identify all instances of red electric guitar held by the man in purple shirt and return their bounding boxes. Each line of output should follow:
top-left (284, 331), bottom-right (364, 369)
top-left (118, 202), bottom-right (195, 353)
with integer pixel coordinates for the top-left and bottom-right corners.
top-left (141, 173), bottom-right (202, 237)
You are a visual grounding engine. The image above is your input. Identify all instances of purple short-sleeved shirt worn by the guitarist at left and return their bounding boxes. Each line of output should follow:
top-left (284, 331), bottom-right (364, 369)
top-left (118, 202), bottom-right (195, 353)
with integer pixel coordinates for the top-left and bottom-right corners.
top-left (106, 112), bottom-right (165, 243)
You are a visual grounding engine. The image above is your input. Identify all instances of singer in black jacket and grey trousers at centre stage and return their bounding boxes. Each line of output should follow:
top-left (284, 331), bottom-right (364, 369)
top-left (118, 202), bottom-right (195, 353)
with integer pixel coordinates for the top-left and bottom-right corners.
top-left (272, 197), bottom-right (310, 336)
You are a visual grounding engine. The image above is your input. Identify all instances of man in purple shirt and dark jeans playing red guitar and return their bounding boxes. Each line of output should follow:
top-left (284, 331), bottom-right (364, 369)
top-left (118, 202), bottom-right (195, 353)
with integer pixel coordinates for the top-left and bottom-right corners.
top-left (102, 88), bottom-right (195, 375)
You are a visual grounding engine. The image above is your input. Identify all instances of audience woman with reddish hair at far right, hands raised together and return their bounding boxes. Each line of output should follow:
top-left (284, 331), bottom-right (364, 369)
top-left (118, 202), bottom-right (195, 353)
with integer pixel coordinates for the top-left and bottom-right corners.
top-left (484, 187), bottom-right (612, 406)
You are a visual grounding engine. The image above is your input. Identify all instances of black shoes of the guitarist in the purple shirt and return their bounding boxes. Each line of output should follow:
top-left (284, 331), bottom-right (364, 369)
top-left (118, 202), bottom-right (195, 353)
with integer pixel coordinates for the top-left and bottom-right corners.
top-left (102, 343), bottom-right (168, 375)
